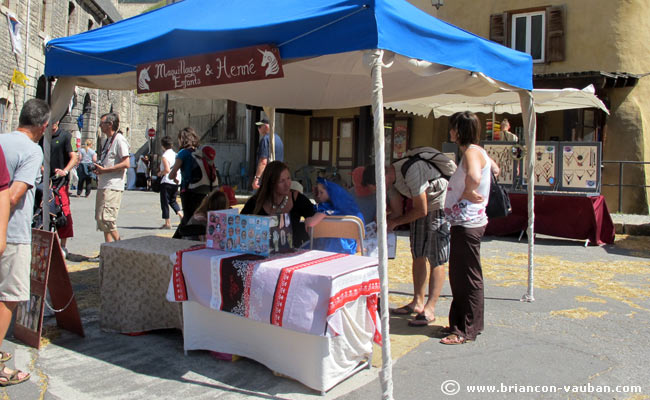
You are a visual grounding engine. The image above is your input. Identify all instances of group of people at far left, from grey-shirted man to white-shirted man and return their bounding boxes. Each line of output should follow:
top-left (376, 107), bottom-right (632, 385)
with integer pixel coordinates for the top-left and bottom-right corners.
top-left (0, 99), bottom-right (135, 386)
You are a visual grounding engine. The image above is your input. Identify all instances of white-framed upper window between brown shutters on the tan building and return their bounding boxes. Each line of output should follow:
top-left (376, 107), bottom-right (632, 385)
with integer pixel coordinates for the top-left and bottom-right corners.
top-left (510, 12), bottom-right (545, 62)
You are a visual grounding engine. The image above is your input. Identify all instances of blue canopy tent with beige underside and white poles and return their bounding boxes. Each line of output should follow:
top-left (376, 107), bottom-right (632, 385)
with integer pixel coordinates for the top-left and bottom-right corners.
top-left (45, 0), bottom-right (535, 398)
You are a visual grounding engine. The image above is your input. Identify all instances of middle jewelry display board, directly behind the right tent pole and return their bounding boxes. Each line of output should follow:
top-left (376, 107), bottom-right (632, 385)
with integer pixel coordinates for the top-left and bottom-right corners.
top-left (519, 142), bottom-right (559, 190)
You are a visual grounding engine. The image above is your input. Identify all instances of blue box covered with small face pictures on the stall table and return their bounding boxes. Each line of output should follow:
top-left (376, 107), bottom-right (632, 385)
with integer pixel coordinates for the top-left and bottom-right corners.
top-left (206, 209), bottom-right (293, 257)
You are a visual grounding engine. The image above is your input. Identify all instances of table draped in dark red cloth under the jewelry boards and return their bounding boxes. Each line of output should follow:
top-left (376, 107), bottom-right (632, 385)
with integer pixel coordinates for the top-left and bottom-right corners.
top-left (485, 193), bottom-right (615, 246)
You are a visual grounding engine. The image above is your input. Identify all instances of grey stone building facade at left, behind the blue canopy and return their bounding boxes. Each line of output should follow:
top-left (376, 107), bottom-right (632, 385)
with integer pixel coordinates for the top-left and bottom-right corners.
top-left (0, 0), bottom-right (158, 152)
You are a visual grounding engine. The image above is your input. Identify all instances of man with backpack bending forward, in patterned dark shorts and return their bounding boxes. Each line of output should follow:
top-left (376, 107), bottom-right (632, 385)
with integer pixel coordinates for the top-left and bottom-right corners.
top-left (362, 147), bottom-right (456, 326)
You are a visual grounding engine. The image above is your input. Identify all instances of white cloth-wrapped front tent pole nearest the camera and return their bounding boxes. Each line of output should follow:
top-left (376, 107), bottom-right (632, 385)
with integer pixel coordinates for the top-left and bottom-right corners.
top-left (370, 49), bottom-right (393, 399)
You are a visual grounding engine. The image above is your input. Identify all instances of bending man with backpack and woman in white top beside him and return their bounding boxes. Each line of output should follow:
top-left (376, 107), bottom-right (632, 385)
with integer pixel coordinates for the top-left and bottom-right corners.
top-left (363, 111), bottom-right (499, 345)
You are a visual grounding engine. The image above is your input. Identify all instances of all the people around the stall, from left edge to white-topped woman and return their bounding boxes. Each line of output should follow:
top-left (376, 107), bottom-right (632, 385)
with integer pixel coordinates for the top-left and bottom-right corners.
top-left (0, 99), bottom-right (499, 386)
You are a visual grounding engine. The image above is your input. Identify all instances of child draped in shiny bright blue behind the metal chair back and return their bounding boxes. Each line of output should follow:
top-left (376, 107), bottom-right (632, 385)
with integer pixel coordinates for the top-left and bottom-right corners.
top-left (307, 178), bottom-right (365, 254)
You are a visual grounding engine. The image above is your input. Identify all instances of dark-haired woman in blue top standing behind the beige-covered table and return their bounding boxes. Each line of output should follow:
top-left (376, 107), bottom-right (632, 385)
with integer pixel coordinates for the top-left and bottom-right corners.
top-left (168, 127), bottom-right (208, 230)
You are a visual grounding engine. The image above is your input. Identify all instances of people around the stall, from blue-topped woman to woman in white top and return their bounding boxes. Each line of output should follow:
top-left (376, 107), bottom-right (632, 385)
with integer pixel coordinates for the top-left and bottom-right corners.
top-left (161, 112), bottom-right (499, 344)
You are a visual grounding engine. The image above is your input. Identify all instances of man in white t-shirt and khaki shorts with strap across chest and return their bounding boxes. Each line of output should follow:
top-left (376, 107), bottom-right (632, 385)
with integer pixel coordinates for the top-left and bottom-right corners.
top-left (93, 113), bottom-right (129, 242)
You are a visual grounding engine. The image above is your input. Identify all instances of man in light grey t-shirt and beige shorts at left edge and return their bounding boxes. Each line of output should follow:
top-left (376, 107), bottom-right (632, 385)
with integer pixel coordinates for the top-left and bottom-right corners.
top-left (0, 99), bottom-right (50, 386)
